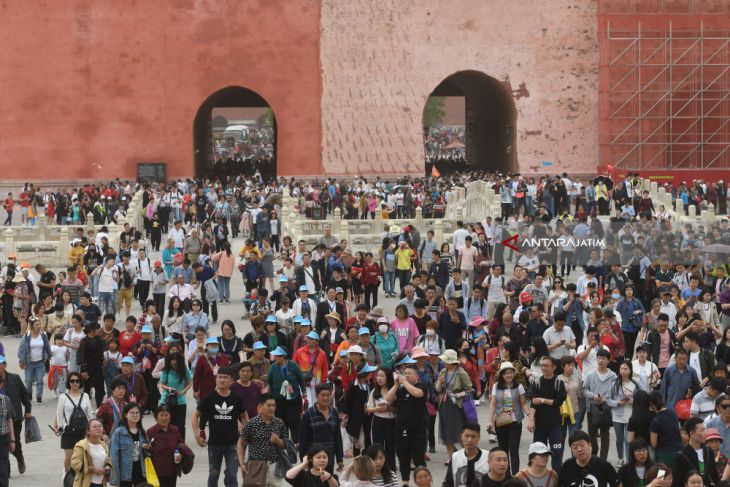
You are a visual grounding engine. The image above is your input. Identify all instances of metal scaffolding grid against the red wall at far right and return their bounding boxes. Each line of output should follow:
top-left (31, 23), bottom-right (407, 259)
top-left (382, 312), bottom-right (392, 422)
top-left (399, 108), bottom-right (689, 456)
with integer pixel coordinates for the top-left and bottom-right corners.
top-left (602, 21), bottom-right (730, 170)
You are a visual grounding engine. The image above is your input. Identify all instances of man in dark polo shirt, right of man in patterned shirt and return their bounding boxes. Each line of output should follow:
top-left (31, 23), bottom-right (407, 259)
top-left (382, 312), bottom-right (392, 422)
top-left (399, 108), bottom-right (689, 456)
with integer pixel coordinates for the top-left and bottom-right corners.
top-left (299, 384), bottom-right (342, 473)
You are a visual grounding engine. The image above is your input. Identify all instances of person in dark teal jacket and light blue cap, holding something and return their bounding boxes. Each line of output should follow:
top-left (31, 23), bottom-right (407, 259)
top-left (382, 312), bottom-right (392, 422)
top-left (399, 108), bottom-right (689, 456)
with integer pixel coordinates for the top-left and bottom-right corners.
top-left (266, 346), bottom-right (308, 439)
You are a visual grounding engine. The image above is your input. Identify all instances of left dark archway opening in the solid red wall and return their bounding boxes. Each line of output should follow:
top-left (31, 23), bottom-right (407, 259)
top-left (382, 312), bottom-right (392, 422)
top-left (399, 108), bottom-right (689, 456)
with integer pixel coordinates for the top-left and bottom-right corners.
top-left (193, 86), bottom-right (278, 181)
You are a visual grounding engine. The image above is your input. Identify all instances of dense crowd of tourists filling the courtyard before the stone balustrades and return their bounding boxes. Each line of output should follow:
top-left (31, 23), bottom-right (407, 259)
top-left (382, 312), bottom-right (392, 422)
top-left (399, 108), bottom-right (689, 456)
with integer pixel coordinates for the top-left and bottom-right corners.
top-left (0, 171), bottom-right (730, 487)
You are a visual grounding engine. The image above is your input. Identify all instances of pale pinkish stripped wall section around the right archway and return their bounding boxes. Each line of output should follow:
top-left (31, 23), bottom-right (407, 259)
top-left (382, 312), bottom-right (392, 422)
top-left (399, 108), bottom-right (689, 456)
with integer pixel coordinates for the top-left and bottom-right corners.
top-left (320, 0), bottom-right (598, 175)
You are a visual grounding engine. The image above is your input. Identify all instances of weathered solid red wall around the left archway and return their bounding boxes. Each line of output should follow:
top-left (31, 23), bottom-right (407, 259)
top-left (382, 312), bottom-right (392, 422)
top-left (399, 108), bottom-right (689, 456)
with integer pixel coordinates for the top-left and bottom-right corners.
top-left (0, 0), bottom-right (322, 179)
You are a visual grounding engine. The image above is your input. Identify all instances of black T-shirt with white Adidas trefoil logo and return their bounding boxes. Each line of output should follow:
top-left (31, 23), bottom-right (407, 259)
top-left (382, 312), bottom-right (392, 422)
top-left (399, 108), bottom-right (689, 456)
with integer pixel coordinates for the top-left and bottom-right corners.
top-left (198, 390), bottom-right (245, 446)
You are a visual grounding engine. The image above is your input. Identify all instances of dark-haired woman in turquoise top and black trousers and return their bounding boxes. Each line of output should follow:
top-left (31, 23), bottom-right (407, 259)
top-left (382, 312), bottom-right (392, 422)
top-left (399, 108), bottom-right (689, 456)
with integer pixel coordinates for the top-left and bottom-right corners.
top-left (159, 347), bottom-right (193, 441)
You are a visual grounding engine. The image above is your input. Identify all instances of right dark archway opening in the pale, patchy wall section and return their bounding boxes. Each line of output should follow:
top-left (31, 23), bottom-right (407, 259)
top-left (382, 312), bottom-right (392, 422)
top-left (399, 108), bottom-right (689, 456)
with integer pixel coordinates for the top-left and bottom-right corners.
top-left (423, 71), bottom-right (517, 174)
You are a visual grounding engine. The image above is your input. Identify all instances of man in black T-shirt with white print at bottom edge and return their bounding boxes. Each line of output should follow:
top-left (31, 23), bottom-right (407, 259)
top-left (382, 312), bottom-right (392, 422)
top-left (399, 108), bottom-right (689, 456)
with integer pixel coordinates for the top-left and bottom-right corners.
top-left (558, 430), bottom-right (618, 487)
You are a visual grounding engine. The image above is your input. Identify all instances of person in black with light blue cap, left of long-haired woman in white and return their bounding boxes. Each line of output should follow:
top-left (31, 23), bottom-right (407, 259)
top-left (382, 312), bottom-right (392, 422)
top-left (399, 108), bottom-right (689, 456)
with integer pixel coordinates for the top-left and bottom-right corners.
top-left (340, 362), bottom-right (377, 456)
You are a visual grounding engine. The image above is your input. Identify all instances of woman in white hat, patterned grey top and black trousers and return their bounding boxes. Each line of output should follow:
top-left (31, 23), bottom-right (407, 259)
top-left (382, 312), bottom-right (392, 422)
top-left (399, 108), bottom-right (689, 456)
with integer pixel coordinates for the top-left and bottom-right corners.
top-left (436, 350), bottom-right (474, 458)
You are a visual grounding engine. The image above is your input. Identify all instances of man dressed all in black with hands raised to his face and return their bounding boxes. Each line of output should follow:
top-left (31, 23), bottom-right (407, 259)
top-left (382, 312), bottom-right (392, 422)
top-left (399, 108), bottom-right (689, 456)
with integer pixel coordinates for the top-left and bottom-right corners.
top-left (385, 364), bottom-right (426, 483)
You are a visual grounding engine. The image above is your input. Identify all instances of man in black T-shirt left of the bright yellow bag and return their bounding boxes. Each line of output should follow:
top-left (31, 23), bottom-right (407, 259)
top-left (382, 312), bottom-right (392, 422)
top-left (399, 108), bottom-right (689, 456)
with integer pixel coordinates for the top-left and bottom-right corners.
top-left (527, 356), bottom-right (567, 472)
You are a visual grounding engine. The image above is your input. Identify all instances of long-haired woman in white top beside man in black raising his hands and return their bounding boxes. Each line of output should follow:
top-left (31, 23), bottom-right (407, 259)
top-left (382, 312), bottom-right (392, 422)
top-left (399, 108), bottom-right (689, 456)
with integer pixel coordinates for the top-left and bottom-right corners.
top-left (366, 366), bottom-right (396, 477)
